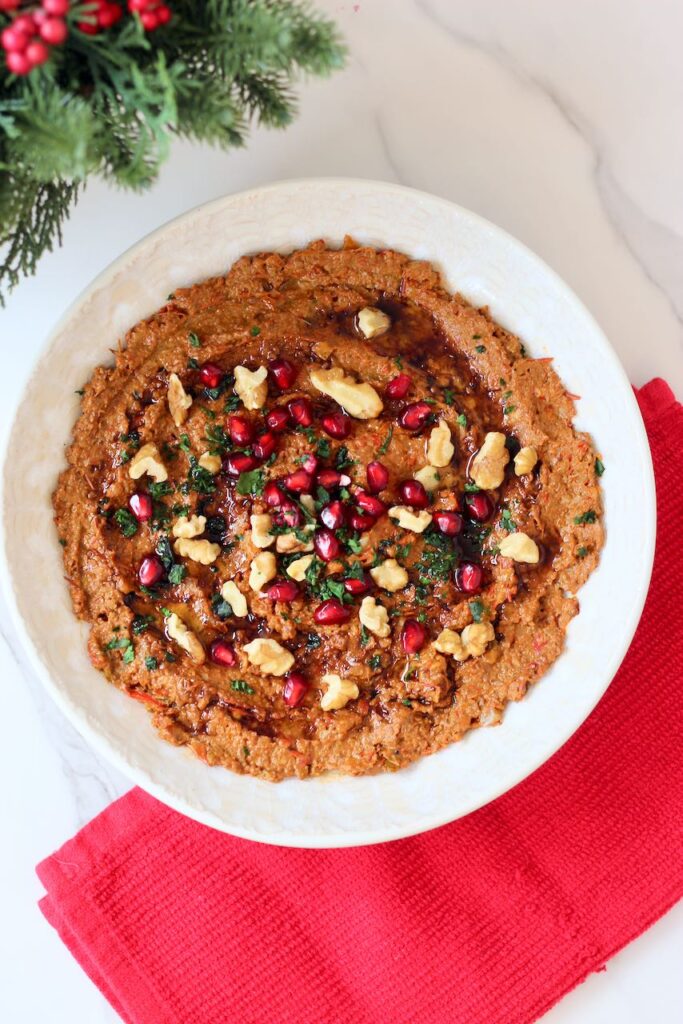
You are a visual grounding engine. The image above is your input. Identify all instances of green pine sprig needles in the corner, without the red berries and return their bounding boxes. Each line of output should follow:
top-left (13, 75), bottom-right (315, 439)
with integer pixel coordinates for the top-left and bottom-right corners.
top-left (0, 0), bottom-right (344, 303)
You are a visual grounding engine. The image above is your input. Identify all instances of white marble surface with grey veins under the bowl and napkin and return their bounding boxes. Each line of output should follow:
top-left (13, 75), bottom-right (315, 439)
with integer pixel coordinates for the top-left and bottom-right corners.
top-left (0, 0), bottom-right (683, 1024)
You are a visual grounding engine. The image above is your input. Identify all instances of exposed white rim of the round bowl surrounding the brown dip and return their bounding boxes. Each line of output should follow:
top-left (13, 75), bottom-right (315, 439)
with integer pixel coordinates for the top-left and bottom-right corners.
top-left (2, 179), bottom-right (655, 847)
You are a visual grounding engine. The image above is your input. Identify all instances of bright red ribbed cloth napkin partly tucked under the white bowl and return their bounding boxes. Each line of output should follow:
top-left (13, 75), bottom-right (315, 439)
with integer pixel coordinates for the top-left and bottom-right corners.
top-left (38, 381), bottom-right (683, 1024)
